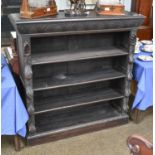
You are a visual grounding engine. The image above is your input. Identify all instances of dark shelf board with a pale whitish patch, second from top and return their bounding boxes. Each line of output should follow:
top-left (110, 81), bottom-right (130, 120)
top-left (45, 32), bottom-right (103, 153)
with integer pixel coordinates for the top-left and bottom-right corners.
top-left (33, 68), bottom-right (125, 91)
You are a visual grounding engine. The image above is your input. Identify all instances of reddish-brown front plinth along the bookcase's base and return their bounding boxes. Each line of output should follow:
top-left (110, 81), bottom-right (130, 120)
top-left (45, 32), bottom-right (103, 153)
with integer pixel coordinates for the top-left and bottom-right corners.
top-left (27, 114), bottom-right (128, 146)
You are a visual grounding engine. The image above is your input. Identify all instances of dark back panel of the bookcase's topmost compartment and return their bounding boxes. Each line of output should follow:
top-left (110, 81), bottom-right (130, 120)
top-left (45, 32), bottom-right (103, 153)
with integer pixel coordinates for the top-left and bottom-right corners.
top-left (31, 31), bottom-right (129, 55)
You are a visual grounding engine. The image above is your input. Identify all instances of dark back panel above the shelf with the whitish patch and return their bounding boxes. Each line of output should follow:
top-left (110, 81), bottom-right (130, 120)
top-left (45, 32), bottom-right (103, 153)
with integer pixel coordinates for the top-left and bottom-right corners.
top-left (32, 56), bottom-right (127, 80)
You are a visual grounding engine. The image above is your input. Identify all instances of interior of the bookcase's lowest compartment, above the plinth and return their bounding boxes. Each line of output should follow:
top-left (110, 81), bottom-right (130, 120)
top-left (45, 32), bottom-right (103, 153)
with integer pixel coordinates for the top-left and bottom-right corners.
top-left (36, 103), bottom-right (127, 133)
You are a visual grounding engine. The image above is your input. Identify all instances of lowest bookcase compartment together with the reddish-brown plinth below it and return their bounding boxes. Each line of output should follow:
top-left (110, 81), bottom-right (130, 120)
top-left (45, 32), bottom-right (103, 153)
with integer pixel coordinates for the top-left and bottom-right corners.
top-left (28, 104), bottom-right (128, 145)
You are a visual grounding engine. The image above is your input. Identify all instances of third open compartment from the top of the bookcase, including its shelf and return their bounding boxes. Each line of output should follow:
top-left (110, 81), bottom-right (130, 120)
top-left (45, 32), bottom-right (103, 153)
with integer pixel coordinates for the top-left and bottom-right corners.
top-left (34, 79), bottom-right (124, 114)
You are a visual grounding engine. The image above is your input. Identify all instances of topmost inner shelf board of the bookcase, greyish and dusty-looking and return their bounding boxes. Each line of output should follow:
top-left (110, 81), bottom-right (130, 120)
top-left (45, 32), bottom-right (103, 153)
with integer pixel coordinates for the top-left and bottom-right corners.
top-left (32, 47), bottom-right (128, 65)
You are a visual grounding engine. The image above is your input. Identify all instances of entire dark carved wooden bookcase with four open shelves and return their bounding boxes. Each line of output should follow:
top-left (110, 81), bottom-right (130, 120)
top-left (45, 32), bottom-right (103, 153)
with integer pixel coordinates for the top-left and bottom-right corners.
top-left (9, 12), bottom-right (144, 145)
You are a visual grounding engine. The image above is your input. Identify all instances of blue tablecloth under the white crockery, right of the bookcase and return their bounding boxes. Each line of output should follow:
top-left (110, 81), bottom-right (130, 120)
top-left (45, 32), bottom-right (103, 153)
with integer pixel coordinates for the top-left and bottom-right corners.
top-left (132, 46), bottom-right (153, 110)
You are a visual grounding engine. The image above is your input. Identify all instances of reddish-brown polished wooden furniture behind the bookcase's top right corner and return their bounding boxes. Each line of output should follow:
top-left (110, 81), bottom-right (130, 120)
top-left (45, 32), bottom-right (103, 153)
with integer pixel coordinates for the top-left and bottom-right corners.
top-left (131, 0), bottom-right (153, 40)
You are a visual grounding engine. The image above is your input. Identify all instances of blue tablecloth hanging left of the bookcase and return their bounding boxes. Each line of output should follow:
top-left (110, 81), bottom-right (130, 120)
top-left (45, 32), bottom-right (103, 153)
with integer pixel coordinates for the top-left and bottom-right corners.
top-left (1, 54), bottom-right (29, 137)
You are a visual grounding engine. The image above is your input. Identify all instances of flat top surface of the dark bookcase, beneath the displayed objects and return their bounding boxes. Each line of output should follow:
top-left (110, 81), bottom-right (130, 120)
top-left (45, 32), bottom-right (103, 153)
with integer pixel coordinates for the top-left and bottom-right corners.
top-left (10, 11), bottom-right (144, 24)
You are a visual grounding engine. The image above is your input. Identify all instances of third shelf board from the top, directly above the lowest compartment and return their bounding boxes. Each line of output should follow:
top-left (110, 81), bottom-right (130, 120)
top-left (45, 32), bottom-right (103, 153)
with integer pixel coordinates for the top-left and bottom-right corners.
top-left (34, 88), bottom-right (124, 114)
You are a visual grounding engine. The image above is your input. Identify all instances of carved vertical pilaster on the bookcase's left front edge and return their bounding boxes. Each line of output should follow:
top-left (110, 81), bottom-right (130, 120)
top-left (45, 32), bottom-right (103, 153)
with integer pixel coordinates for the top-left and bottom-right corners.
top-left (22, 36), bottom-right (36, 134)
